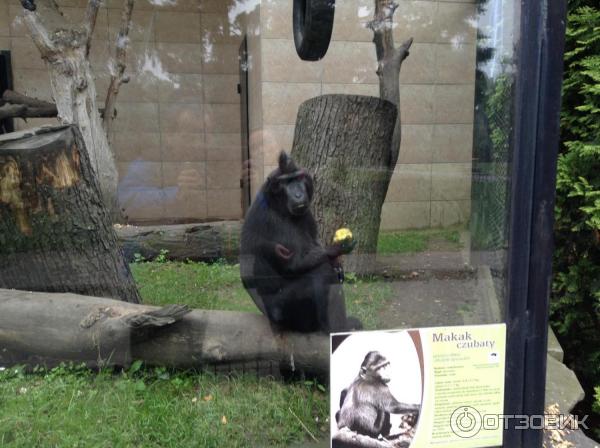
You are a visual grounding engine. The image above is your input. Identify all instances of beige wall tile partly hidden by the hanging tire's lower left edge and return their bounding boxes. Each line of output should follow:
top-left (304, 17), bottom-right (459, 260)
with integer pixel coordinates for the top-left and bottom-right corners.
top-left (261, 39), bottom-right (323, 82)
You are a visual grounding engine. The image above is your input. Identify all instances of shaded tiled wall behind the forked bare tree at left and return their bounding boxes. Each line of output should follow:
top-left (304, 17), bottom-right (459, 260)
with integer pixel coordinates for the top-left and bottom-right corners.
top-left (0, 0), bottom-right (241, 222)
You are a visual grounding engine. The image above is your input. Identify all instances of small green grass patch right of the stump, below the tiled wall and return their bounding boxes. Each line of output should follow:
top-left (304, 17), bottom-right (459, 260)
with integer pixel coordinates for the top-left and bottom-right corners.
top-left (377, 228), bottom-right (461, 255)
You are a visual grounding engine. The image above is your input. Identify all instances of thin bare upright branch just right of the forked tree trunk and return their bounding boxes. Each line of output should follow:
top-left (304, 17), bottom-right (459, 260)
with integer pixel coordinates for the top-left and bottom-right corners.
top-left (103, 0), bottom-right (134, 140)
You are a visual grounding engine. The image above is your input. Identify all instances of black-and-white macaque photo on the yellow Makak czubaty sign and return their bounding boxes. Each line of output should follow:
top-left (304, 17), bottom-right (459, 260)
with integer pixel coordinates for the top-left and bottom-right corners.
top-left (330, 331), bottom-right (423, 448)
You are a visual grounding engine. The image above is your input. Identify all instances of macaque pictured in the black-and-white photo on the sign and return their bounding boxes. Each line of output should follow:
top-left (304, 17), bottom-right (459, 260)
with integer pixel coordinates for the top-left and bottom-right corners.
top-left (335, 351), bottom-right (421, 438)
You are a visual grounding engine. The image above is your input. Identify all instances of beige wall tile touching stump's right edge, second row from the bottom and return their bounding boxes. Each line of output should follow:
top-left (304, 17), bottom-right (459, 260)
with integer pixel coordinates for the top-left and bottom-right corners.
top-left (385, 164), bottom-right (431, 202)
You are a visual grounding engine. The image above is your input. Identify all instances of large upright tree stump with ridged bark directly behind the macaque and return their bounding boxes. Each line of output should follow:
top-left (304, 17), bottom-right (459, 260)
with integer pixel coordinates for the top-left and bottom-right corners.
top-left (292, 95), bottom-right (397, 274)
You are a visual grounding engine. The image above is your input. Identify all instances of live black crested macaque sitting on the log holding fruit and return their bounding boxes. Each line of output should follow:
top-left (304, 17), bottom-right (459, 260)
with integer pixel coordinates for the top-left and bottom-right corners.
top-left (240, 152), bottom-right (360, 332)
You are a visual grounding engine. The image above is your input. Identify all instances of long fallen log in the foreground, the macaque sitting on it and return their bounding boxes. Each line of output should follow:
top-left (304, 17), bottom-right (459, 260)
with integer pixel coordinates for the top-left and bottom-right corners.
top-left (0, 289), bottom-right (329, 374)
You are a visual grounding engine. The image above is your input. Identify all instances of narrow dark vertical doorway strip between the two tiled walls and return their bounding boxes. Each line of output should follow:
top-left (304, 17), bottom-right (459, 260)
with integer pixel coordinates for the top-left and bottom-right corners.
top-left (238, 37), bottom-right (252, 216)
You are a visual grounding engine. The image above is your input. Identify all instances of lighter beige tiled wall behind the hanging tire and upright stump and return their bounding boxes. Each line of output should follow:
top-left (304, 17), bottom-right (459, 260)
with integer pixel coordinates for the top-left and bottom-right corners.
top-left (255, 0), bottom-right (476, 229)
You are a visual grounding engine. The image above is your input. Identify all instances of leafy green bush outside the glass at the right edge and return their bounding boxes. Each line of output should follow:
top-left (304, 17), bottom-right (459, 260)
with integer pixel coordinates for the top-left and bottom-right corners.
top-left (551, 0), bottom-right (600, 436)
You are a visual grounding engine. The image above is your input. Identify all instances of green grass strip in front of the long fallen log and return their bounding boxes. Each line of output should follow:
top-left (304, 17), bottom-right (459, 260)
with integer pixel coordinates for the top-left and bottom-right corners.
top-left (0, 366), bottom-right (329, 448)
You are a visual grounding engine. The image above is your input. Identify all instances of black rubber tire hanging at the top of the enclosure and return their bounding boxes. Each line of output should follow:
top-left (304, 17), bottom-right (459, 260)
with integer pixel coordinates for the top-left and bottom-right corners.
top-left (293, 0), bottom-right (335, 61)
